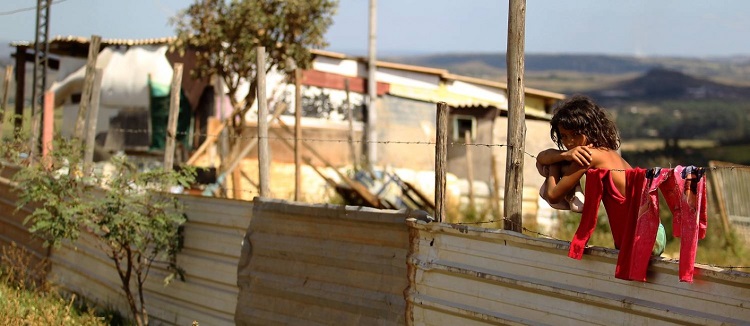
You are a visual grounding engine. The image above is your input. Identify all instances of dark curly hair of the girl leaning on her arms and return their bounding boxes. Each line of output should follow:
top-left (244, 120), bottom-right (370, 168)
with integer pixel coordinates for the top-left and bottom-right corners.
top-left (550, 95), bottom-right (620, 150)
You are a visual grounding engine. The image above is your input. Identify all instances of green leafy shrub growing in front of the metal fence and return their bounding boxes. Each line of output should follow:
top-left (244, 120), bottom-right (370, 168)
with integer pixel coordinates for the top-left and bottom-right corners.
top-left (14, 140), bottom-right (194, 325)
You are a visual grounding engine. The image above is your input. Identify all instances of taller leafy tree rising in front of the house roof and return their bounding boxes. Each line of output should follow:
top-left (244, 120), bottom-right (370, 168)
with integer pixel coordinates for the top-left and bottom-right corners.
top-left (172, 0), bottom-right (338, 132)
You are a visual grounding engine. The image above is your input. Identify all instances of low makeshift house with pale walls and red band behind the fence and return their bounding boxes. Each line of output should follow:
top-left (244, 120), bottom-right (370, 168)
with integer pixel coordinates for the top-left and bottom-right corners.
top-left (13, 37), bottom-right (564, 219)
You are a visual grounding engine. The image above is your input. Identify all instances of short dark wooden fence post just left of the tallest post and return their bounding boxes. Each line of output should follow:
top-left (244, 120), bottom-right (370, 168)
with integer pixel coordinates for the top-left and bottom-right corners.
top-left (435, 102), bottom-right (449, 222)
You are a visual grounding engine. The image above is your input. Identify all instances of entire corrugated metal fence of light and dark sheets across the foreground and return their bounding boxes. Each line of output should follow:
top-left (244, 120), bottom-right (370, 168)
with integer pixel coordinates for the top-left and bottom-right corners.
top-left (0, 180), bottom-right (750, 325)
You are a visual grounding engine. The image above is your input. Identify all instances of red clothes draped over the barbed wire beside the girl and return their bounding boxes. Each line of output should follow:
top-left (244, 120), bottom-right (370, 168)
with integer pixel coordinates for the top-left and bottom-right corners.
top-left (568, 166), bottom-right (707, 282)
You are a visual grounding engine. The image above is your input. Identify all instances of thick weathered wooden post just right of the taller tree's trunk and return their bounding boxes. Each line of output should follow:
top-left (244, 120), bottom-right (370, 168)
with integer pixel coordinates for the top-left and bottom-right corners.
top-left (258, 46), bottom-right (271, 198)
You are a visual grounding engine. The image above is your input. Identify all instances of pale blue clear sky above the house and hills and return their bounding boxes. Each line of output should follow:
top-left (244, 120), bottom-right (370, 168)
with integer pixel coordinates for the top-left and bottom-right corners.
top-left (0, 0), bottom-right (750, 57)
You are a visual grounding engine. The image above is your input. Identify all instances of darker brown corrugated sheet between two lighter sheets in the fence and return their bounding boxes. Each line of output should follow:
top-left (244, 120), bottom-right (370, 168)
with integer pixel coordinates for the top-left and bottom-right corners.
top-left (235, 199), bottom-right (409, 325)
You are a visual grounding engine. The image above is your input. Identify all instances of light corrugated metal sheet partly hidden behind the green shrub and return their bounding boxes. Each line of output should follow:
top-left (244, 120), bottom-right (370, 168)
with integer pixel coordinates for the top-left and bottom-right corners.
top-left (50, 196), bottom-right (253, 325)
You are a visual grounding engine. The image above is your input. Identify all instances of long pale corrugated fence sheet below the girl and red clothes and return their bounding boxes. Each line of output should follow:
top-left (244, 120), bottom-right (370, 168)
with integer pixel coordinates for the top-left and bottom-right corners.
top-left (406, 219), bottom-right (750, 325)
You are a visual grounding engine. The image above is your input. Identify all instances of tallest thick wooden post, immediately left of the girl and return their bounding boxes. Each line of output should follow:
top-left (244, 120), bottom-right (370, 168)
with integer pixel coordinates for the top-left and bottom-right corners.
top-left (504, 0), bottom-right (526, 232)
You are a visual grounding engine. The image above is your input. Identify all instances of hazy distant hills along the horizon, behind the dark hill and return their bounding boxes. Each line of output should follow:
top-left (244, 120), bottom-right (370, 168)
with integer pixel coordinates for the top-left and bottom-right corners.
top-left (383, 53), bottom-right (750, 93)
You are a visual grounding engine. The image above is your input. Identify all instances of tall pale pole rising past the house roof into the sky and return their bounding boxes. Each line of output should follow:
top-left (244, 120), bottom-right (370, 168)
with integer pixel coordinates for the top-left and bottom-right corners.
top-left (367, 0), bottom-right (378, 170)
